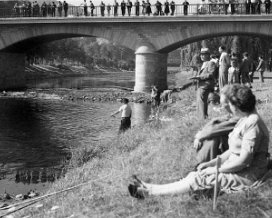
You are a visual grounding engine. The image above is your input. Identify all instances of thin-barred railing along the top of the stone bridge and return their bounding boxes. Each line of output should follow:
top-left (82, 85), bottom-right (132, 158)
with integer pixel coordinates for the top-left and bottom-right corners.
top-left (0, 3), bottom-right (271, 18)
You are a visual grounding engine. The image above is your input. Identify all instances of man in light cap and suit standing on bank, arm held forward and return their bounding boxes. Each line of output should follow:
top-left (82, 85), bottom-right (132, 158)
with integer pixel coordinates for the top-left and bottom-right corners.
top-left (191, 48), bottom-right (216, 119)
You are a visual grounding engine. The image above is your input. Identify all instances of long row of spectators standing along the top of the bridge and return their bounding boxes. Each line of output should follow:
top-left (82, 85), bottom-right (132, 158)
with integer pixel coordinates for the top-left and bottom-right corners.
top-left (10, 0), bottom-right (271, 17)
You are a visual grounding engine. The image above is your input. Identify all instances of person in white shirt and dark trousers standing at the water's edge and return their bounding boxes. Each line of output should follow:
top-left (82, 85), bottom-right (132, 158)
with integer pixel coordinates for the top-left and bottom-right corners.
top-left (111, 98), bottom-right (132, 133)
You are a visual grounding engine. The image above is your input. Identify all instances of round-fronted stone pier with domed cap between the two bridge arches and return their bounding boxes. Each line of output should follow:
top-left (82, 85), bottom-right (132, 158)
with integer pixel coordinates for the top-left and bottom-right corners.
top-left (134, 46), bottom-right (168, 92)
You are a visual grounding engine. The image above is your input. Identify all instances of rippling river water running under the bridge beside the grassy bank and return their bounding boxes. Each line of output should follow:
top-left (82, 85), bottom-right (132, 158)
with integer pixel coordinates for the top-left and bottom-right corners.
top-left (0, 73), bottom-right (153, 195)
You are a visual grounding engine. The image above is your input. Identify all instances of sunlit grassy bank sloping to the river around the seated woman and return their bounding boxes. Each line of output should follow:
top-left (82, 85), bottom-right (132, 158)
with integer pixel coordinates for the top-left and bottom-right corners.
top-left (16, 72), bottom-right (272, 218)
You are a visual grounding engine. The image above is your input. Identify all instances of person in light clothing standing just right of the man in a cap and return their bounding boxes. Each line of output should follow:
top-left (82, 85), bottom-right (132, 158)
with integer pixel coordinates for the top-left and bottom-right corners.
top-left (218, 45), bottom-right (230, 91)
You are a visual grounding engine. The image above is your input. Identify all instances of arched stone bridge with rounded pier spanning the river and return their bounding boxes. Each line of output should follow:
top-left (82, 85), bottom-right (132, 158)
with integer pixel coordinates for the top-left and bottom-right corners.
top-left (0, 15), bottom-right (272, 92)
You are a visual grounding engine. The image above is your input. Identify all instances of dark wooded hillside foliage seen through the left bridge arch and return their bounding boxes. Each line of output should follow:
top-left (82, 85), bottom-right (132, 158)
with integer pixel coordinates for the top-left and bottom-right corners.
top-left (27, 37), bottom-right (135, 70)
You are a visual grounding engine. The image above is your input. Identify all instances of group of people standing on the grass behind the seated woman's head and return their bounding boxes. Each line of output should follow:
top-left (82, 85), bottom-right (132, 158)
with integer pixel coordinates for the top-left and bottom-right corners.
top-left (191, 46), bottom-right (265, 119)
